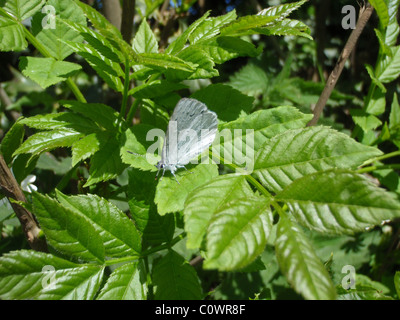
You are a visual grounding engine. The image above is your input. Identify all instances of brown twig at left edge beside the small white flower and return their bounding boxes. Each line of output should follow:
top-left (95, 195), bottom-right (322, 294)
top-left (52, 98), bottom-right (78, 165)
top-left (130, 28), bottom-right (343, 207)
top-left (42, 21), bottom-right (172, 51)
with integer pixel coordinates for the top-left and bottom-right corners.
top-left (0, 154), bottom-right (47, 251)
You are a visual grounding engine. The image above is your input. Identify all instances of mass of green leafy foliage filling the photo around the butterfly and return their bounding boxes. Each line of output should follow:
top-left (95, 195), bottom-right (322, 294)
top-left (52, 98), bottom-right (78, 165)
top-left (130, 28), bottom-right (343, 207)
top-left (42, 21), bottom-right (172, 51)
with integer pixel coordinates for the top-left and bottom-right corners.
top-left (0, 0), bottom-right (400, 300)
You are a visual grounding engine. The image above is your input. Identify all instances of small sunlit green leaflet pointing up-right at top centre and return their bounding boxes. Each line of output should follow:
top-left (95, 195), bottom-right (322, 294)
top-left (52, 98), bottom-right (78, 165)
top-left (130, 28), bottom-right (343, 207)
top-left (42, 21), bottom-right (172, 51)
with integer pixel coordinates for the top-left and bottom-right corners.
top-left (188, 9), bottom-right (237, 44)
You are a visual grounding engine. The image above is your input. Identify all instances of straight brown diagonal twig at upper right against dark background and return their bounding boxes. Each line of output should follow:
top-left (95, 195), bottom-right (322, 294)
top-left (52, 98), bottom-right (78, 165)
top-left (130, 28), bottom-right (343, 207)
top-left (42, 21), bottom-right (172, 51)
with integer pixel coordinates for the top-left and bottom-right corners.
top-left (308, 3), bottom-right (373, 126)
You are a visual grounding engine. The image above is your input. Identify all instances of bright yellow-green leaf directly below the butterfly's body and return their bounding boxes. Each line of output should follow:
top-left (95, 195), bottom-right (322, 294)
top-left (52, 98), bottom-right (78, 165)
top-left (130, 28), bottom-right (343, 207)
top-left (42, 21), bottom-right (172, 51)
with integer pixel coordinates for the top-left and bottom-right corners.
top-left (154, 164), bottom-right (218, 215)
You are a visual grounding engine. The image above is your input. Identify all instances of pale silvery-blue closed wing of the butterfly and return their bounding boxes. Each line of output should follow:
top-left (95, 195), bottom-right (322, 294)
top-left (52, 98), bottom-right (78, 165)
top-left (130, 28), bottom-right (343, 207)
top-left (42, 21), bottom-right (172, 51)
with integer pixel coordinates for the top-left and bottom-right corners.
top-left (162, 98), bottom-right (218, 165)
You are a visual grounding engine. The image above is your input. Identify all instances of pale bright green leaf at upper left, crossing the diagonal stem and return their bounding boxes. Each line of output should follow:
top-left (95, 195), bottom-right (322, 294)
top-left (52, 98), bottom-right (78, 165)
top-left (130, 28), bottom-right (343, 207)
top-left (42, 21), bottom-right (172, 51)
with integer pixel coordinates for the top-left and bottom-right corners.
top-left (19, 57), bottom-right (82, 89)
